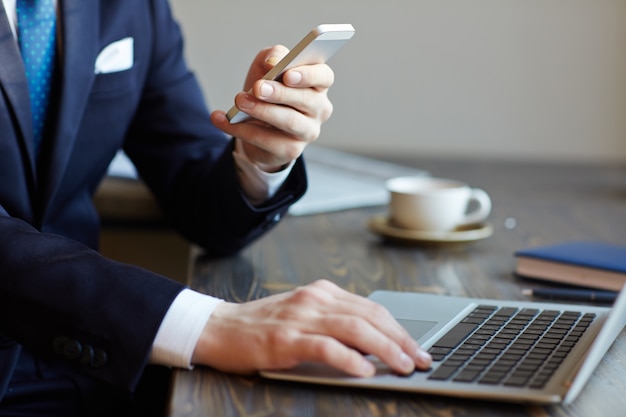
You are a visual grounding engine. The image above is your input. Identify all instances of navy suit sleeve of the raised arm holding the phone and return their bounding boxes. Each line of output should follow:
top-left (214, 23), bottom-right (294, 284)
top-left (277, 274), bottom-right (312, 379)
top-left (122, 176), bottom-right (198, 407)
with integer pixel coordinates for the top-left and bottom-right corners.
top-left (120, 0), bottom-right (306, 255)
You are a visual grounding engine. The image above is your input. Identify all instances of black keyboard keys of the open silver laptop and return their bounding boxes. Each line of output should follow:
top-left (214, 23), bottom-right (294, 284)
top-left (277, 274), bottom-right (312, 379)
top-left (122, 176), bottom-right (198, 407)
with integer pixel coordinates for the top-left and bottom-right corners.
top-left (428, 305), bottom-right (595, 389)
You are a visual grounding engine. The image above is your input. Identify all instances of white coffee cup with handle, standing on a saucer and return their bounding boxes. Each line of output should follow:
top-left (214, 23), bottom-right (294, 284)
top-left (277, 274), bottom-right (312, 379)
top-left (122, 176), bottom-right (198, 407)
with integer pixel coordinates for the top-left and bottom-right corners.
top-left (386, 176), bottom-right (491, 231)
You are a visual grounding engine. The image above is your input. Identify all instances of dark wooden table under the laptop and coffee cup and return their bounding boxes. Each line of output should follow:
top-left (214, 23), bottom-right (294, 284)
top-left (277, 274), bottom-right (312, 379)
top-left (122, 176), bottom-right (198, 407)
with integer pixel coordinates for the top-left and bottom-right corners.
top-left (169, 160), bottom-right (626, 417)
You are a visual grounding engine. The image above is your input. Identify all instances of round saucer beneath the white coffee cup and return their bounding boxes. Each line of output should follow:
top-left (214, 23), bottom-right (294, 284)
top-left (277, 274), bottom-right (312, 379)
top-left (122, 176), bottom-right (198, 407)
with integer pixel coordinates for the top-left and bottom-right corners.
top-left (367, 214), bottom-right (493, 244)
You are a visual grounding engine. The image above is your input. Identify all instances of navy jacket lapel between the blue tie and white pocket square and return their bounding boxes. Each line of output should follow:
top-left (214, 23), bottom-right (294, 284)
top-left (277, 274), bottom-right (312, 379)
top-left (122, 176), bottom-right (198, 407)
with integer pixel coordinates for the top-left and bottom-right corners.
top-left (40, 0), bottom-right (99, 211)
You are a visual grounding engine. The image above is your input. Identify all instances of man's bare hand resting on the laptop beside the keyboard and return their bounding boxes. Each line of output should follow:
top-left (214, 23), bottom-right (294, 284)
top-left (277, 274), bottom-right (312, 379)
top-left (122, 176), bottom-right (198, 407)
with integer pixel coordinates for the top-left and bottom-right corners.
top-left (193, 280), bottom-right (431, 377)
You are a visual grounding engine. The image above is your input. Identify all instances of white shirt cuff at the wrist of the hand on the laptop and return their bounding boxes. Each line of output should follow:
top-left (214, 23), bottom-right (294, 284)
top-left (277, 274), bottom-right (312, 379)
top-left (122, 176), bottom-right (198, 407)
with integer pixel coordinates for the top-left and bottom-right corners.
top-left (150, 289), bottom-right (223, 369)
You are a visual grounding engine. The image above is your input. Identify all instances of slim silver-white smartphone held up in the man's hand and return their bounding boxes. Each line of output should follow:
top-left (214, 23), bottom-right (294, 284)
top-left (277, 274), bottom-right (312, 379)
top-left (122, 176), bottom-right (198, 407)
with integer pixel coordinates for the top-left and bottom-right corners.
top-left (226, 24), bottom-right (354, 123)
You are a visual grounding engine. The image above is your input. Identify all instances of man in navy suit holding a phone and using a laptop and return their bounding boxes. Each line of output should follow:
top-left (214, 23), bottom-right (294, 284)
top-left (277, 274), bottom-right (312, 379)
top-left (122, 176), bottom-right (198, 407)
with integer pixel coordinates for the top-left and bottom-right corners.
top-left (0, 0), bottom-right (429, 416)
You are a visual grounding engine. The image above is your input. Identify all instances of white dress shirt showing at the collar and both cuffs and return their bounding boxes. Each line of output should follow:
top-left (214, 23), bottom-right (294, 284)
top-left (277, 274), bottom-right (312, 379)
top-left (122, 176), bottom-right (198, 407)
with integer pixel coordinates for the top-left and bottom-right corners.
top-left (2, 0), bottom-right (294, 368)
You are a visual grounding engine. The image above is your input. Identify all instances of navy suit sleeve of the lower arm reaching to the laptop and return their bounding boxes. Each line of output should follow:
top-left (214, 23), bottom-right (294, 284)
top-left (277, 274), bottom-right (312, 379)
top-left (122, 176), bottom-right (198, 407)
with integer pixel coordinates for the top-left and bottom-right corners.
top-left (0, 215), bottom-right (183, 389)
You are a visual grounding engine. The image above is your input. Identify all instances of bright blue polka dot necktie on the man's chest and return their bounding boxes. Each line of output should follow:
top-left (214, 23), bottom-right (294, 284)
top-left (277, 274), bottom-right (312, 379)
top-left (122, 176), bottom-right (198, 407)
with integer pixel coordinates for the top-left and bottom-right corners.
top-left (16, 0), bottom-right (56, 150)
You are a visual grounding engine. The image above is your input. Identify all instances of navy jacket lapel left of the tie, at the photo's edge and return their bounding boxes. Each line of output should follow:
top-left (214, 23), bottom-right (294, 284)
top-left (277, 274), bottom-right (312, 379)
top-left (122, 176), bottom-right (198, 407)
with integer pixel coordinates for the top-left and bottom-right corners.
top-left (0, 1), bottom-right (35, 171)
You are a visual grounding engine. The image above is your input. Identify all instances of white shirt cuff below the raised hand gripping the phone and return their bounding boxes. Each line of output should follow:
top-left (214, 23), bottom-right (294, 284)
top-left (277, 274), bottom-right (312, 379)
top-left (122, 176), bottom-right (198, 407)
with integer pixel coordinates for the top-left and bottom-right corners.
top-left (233, 139), bottom-right (296, 206)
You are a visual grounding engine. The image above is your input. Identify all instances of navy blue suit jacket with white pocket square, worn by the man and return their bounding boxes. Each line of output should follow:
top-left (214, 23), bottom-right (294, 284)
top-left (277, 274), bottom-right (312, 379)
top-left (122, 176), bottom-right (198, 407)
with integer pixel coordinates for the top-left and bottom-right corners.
top-left (0, 0), bottom-right (306, 398)
